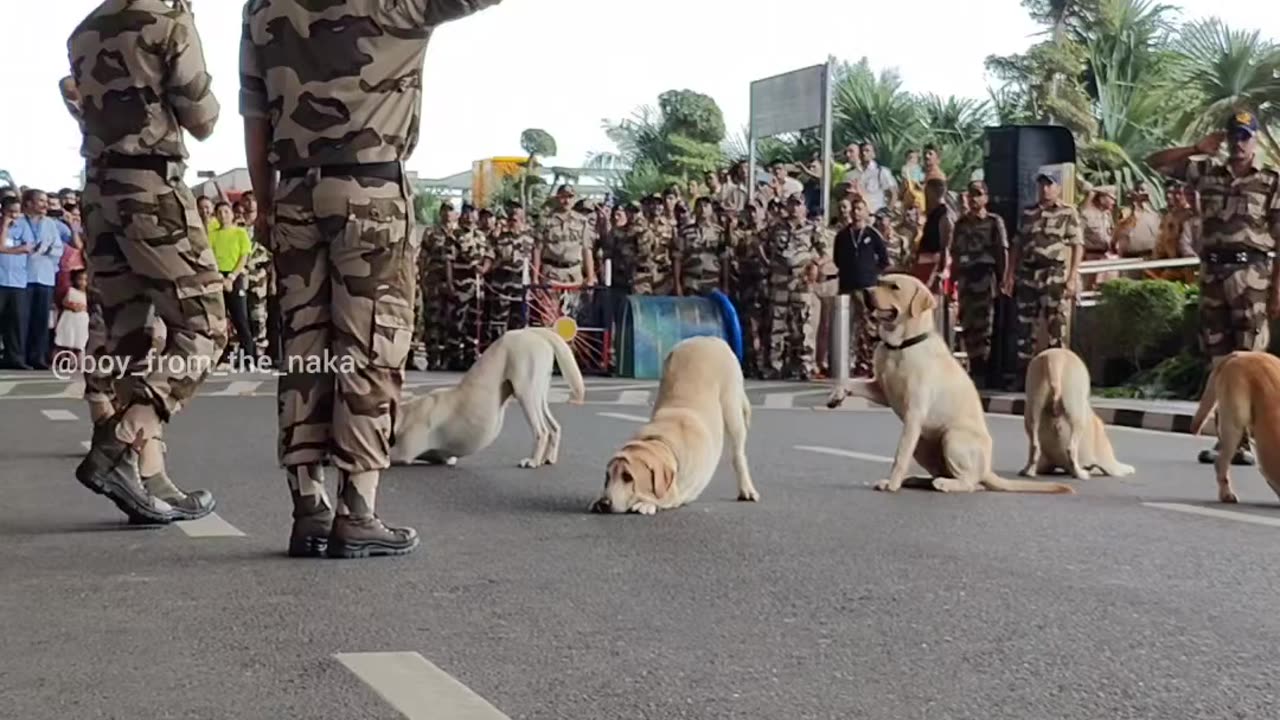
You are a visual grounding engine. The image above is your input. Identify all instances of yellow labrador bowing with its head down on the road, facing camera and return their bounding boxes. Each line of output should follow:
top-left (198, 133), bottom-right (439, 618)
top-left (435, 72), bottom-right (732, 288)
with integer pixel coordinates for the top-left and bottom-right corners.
top-left (591, 337), bottom-right (760, 515)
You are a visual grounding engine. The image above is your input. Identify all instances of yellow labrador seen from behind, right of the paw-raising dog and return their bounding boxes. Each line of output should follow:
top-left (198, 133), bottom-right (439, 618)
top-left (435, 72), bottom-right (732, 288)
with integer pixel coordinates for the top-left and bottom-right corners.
top-left (1020, 347), bottom-right (1134, 480)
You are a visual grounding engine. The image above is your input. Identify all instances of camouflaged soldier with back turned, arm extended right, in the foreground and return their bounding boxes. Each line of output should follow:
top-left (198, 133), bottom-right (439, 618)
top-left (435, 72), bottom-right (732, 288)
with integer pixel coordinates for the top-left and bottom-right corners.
top-left (241, 0), bottom-right (499, 557)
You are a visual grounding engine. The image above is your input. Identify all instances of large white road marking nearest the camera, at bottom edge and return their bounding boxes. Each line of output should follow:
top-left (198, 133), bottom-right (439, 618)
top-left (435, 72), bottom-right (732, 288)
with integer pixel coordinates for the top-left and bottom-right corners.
top-left (334, 652), bottom-right (511, 720)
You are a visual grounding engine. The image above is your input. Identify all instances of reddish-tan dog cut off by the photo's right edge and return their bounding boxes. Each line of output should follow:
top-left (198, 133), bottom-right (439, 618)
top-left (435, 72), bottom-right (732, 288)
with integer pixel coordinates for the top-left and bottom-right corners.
top-left (1192, 351), bottom-right (1280, 502)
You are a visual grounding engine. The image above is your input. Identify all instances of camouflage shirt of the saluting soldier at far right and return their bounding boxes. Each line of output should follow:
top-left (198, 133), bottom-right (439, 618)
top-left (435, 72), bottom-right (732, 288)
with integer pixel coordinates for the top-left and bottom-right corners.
top-left (1179, 158), bottom-right (1280, 252)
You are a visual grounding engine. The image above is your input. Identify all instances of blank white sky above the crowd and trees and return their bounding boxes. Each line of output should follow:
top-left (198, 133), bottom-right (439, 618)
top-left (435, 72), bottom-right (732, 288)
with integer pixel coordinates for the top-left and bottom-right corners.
top-left (0, 0), bottom-right (1280, 190)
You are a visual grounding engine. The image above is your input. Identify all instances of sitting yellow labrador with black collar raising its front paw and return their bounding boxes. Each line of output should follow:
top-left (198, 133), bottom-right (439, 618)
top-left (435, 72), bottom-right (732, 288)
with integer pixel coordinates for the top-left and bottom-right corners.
top-left (827, 274), bottom-right (1074, 493)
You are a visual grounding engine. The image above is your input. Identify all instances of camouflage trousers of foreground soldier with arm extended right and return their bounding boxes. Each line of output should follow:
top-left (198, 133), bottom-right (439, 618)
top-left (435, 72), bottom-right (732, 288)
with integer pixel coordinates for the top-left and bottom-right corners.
top-left (271, 171), bottom-right (417, 474)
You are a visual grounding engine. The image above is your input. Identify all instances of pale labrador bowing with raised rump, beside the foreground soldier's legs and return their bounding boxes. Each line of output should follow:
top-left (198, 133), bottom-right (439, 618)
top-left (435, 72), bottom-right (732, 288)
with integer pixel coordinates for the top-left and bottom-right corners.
top-left (390, 328), bottom-right (586, 468)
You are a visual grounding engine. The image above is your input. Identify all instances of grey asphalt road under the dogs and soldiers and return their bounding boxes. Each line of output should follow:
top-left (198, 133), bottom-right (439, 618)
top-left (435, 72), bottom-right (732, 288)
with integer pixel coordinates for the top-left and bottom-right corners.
top-left (0, 378), bottom-right (1280, 720)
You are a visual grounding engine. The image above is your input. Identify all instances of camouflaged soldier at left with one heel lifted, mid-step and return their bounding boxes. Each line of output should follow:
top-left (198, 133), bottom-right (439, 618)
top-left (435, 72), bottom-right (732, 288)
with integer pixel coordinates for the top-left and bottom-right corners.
top-left (67, 0), bottom-right (227, 524)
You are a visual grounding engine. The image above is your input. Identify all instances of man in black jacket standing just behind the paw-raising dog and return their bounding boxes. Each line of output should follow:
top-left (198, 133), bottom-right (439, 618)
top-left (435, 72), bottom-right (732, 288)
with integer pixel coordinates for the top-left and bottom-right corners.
top-left (832, 197), bottom-right (888, 377)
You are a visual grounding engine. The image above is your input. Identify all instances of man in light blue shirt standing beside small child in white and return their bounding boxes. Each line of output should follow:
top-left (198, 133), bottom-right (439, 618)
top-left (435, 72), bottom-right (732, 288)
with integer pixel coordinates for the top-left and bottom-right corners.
top-left (9, 190), bottom-right (72, 370)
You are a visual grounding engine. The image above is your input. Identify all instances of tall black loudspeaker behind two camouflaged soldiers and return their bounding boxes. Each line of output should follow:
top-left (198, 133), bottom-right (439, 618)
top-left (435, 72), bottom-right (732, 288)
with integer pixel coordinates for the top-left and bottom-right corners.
top-left (983, 126), bottom-right (1075, 387)
